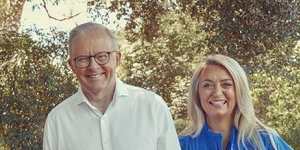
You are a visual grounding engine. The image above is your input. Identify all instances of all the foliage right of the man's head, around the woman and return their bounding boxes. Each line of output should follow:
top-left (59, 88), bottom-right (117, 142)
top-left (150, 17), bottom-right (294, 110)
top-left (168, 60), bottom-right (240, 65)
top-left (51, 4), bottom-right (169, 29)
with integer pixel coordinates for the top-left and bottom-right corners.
top-left (92, 0), bottom-right (300, 148)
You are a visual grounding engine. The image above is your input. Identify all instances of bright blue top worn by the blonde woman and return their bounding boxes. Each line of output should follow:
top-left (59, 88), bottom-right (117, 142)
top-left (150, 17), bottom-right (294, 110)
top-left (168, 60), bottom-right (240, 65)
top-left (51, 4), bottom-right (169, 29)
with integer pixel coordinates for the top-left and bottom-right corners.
top-left (179, 123), bottom-right (292, 150)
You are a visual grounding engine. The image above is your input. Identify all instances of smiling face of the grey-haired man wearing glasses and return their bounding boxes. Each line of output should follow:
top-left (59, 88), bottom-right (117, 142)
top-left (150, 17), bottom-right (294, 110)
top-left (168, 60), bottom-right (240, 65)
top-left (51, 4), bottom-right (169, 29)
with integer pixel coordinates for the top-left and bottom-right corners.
top-left (69, 34), bottom-right (121, 94)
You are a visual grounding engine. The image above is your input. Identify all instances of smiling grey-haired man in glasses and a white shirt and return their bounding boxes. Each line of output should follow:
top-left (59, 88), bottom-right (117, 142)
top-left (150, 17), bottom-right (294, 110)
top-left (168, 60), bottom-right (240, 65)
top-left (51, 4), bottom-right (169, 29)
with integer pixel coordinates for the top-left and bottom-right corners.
top-left (43, 23), bottom-right (180, 150)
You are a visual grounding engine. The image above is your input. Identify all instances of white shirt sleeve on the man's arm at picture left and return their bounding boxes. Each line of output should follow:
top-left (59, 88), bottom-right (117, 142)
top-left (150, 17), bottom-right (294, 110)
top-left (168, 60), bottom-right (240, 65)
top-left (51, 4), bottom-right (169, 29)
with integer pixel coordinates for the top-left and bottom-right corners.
top-left (43, 116), bottom-right (58, 150)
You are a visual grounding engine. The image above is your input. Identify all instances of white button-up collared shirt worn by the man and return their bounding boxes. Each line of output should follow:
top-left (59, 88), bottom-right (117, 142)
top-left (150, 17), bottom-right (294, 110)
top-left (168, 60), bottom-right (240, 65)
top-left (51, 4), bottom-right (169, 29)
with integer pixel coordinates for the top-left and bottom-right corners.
top-left (43, 80), bottom-right (180, 150)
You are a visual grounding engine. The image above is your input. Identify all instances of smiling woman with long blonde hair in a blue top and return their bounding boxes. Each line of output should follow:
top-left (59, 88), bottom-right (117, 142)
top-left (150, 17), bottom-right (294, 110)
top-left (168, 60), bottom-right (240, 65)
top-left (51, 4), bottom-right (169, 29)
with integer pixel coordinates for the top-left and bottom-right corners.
top-left (179, 55), bottom-right (292, 150)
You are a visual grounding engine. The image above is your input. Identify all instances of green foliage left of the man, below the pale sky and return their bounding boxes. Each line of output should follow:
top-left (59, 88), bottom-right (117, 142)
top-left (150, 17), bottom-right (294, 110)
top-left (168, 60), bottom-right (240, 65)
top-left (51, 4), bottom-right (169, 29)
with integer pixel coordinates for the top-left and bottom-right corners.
top-left (0, 30), bottom-right (75, 149)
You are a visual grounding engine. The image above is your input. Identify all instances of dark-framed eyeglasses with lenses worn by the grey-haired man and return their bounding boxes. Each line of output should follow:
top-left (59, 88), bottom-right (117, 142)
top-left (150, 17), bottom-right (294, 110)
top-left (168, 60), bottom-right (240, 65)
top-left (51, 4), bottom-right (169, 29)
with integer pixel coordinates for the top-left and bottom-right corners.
top-left (74, 51), bottom-right (117, 68)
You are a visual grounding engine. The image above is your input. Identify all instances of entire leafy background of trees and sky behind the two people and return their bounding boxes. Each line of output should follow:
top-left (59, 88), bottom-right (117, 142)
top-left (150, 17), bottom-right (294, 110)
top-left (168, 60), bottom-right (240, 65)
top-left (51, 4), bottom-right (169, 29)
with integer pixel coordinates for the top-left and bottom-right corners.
top-left (0, 0), bottom-right (300, 150)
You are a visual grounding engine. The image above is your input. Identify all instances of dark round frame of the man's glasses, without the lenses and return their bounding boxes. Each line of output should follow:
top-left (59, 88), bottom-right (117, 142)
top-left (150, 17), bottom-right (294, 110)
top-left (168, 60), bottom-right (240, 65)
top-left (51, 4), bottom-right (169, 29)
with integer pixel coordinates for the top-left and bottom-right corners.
top-left (73, 51), bottom-right (118, 69)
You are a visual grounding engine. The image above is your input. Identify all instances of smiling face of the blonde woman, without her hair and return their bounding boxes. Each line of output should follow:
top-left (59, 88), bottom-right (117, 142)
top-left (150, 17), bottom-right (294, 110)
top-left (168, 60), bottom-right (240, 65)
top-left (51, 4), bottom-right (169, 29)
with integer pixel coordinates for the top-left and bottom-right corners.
top-left (198, 65), bottom-right (236, 119)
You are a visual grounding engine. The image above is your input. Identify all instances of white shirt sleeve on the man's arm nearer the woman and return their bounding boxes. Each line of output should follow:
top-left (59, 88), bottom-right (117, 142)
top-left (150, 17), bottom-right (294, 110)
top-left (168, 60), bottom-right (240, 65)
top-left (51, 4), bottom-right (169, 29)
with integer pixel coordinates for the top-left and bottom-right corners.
top-left (156, 95), bottom-right (180, 150)
